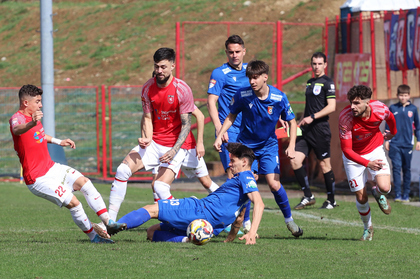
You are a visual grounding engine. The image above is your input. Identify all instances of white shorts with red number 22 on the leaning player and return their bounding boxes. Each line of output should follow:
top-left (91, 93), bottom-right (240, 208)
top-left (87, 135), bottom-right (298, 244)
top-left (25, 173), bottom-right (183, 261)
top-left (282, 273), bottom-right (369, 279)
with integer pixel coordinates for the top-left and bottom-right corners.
top-left (27, 163), bottom-right (83, 207)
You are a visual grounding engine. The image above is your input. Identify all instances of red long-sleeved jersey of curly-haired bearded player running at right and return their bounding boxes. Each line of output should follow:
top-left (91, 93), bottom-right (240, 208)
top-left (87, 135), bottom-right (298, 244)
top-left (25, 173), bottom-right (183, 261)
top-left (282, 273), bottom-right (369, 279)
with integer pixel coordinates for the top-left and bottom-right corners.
top-left (338, 101), bottom-right (397, 166)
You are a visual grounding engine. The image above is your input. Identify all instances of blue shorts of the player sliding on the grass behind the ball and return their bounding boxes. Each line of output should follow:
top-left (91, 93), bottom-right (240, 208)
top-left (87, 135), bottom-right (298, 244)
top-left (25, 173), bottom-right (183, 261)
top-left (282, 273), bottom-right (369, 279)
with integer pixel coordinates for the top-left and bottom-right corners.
top-left (158, 198), bottom-right (207, 232)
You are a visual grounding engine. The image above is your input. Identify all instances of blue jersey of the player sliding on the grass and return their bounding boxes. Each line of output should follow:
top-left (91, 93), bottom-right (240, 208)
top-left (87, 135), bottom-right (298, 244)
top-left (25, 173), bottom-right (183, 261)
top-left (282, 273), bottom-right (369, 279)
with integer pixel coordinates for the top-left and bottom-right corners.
top-left (200, 171), bottom-right (258, 233)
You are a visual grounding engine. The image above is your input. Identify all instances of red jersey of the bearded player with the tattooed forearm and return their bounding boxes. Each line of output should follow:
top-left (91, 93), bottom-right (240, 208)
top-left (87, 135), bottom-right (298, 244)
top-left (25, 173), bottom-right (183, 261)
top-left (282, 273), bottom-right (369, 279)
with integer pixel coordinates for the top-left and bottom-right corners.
top-left (141, 77), bottom-right (196, 149)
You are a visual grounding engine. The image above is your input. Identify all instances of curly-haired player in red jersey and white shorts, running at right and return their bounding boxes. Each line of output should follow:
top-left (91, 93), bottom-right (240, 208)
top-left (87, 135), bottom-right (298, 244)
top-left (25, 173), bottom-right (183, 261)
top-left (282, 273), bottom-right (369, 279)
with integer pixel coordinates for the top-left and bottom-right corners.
top-left (339, 85), bottom-right (397, 240)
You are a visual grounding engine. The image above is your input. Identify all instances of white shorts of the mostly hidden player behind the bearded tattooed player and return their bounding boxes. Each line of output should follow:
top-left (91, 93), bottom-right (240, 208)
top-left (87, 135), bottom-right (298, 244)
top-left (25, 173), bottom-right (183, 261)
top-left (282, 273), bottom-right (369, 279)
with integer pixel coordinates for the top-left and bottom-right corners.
top-left (152, 148), bottom-right (209, 178)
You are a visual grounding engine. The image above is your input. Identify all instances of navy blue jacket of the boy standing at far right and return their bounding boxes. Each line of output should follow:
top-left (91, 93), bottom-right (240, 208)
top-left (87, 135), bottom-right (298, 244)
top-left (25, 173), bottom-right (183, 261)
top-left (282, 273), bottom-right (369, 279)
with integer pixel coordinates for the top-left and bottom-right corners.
top-left (386, 102), bottom-right (420, 147)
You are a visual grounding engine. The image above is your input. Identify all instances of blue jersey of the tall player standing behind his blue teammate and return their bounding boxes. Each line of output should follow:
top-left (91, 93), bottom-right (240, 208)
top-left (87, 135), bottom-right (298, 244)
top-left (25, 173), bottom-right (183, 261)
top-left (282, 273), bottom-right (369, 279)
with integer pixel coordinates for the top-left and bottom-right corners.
top-left (207, 63), bottom-right (249, 133)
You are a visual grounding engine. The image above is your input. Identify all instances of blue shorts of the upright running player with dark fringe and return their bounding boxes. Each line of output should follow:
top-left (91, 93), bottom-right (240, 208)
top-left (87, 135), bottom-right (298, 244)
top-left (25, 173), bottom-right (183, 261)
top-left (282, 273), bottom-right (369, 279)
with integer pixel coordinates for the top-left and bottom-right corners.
top-left (252, 142), bottom-right (280, 174)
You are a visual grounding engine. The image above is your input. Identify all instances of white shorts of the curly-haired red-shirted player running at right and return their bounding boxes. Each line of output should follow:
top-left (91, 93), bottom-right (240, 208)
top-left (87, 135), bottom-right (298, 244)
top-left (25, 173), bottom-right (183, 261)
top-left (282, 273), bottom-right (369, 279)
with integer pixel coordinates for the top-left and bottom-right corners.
top-left (343, 145), bottom-right (391, 192)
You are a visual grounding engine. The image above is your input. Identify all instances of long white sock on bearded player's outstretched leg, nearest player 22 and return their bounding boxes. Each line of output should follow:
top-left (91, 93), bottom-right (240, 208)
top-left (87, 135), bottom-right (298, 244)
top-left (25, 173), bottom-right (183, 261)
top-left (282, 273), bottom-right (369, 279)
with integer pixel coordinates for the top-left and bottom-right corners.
top-left (109, 164), bottom-right (132, 221)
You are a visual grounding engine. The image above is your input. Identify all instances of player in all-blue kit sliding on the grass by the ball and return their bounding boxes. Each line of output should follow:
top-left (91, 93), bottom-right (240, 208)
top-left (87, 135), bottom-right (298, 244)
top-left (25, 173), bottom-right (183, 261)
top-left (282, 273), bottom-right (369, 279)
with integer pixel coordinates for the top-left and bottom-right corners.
top-left (118, 143), bottom-right (264, 244)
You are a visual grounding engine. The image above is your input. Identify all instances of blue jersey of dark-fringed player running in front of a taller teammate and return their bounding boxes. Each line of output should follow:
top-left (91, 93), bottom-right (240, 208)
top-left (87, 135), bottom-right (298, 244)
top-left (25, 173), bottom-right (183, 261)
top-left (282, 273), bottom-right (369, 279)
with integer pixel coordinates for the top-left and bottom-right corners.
top-left (229, 85), bottom-right (295, 149)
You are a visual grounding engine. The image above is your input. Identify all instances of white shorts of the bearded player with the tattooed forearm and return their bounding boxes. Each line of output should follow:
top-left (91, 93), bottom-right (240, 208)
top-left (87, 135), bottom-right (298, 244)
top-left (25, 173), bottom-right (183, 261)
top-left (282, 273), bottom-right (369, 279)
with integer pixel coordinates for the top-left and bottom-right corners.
top-left (132, 141), bottom-right (186, 174)
